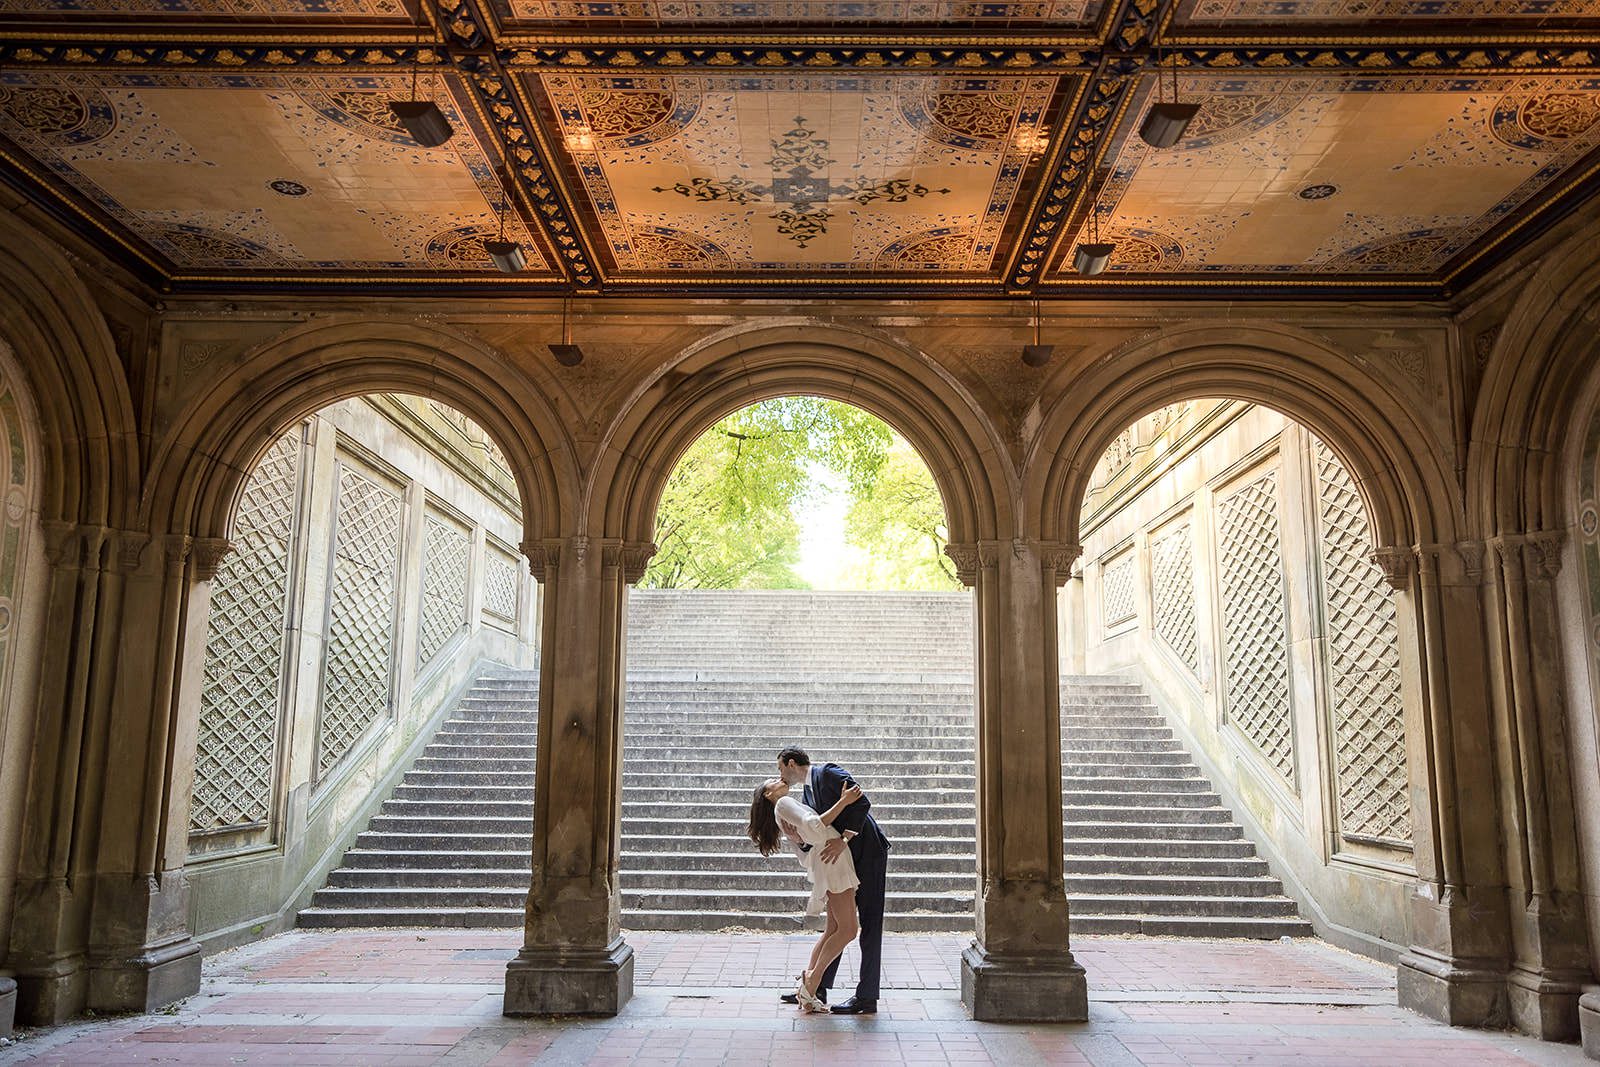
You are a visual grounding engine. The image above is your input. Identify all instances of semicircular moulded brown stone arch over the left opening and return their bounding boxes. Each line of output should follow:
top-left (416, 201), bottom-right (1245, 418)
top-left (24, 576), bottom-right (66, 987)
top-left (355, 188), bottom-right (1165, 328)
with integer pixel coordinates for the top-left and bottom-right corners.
top-left (142, 322), bottom-right (578, 539)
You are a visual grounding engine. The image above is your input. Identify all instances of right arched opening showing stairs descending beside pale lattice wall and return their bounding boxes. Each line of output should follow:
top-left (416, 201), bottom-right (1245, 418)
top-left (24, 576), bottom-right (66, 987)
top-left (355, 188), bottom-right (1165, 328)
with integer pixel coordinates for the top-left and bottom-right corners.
top-left (1062, 398), bottom-right (1426, 960)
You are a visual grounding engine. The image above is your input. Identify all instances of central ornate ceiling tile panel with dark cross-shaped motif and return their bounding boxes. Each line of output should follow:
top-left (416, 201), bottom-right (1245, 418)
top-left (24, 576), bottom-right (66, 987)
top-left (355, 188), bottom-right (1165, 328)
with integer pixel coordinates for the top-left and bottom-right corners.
top-left (536, 74), bottom-right (1062, 277)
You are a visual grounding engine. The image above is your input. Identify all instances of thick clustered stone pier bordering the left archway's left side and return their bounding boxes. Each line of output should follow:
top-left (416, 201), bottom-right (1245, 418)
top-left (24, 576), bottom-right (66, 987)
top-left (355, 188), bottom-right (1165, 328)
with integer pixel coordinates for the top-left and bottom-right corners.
top-left (8, 523), bottom-right (227, 1024)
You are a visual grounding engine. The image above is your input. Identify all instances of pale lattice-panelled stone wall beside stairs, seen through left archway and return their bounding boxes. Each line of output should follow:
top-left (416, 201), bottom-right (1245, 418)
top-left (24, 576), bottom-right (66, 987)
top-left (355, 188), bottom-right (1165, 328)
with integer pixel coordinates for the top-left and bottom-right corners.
top-left (187, 395), bottom-right (538, 947)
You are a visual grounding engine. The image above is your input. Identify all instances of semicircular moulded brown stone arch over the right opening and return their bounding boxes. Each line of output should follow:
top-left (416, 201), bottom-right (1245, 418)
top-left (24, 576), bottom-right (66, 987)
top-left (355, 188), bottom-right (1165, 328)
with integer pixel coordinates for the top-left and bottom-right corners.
top-left (1024, 325), bottom-right (1461, 547)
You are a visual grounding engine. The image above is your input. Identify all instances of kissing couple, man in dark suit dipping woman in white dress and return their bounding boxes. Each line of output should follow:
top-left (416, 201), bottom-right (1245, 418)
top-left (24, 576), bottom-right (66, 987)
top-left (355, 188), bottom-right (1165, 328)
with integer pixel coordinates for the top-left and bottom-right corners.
top-left (749, 747), bottom-right (890, 1016)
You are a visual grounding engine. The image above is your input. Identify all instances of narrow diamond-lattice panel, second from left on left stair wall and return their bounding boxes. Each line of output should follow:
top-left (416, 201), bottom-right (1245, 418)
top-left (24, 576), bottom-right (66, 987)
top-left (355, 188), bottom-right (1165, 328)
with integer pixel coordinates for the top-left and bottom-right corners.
top-left (317, 462), bottom-right (402, 776)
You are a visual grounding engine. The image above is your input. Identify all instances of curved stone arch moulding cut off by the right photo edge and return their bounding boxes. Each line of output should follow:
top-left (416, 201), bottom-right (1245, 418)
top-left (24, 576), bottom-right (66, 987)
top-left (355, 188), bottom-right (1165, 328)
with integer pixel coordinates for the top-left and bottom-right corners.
top-left (1466, 228), bottom-right (1600, 537)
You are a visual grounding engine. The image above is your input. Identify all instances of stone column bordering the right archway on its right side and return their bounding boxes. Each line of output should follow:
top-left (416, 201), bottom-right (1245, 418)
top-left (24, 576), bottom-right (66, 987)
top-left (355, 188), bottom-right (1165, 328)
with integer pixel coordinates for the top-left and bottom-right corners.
top-left (1374, 542), bottom-right (1509, 1027)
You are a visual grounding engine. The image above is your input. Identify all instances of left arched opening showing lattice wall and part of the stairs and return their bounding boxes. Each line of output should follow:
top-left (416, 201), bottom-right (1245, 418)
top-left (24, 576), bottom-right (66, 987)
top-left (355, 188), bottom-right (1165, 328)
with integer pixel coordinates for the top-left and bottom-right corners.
top-left (187, 394), bottom-right (538, 947)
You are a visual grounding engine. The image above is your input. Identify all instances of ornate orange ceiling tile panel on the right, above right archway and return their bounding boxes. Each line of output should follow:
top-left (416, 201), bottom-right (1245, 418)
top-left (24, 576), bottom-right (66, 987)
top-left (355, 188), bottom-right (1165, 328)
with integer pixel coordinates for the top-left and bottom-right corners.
top-left (1056, 75), bottom-right (1600, 277)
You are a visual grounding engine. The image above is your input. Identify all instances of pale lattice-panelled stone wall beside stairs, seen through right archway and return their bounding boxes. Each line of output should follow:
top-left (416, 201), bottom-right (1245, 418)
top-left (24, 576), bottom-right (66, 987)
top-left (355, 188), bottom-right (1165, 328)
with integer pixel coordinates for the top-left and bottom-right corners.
top-left (1077, 400), bottom-right (1416, 958)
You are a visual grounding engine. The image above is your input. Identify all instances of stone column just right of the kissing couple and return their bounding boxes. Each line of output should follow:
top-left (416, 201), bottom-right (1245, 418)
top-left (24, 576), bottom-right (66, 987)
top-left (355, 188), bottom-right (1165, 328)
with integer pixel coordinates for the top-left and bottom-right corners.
top-left (946, 539), bottom-right (1088, 1022)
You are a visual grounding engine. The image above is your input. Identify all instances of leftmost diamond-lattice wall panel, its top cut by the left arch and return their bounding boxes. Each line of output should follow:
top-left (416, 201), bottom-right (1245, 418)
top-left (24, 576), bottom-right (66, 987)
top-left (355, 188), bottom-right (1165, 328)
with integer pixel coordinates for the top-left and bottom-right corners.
top-left (189, 427), bottom-right (301, 833)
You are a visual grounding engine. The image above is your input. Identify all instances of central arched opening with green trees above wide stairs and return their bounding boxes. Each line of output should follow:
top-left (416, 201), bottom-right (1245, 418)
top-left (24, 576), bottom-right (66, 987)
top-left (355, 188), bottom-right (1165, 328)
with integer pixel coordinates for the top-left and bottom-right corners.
top-left (621, 390), bottom-right (976, 998)
